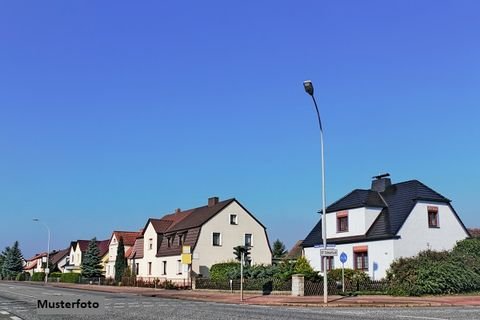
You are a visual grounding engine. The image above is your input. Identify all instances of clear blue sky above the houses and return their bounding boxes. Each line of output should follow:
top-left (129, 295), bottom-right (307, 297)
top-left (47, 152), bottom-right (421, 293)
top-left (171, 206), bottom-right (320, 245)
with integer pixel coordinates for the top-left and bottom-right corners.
top-left (0, 0), bottom-right (480, 256)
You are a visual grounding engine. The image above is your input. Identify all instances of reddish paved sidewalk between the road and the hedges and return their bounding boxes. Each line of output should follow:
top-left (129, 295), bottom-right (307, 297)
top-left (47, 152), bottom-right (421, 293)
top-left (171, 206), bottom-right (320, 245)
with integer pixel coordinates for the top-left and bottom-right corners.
top-left (49, 283), bottom-right (480, 307)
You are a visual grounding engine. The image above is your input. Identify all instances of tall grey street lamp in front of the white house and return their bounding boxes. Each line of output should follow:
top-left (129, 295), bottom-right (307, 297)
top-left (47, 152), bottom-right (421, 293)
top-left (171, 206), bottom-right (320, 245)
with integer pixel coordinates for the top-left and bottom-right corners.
top-left (303, 80), bottom-right (328, 303)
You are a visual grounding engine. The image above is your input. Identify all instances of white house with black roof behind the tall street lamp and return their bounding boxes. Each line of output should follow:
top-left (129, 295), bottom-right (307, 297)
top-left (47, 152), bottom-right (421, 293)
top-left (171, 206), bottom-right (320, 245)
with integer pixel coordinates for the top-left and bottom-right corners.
top-left (303, 174), bottom-right (469, 279)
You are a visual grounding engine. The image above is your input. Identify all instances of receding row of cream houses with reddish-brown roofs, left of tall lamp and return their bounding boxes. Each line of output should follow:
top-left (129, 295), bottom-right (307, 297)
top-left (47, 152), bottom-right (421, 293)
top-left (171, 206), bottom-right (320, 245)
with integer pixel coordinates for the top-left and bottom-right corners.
top-left (24, 197), bottom-right (272, 280)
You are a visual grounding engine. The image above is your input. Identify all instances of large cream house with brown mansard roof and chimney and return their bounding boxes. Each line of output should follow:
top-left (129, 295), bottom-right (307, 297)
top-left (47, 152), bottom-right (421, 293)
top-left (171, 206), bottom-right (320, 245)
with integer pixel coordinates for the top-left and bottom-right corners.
top-left (129, 197), bottom-right (272, 280)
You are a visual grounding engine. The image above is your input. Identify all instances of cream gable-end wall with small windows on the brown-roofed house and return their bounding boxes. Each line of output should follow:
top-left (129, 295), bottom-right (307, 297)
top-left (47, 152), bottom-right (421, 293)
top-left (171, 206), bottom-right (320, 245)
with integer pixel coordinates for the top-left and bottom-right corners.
top-left (192, 202), bottom-right (272, 276)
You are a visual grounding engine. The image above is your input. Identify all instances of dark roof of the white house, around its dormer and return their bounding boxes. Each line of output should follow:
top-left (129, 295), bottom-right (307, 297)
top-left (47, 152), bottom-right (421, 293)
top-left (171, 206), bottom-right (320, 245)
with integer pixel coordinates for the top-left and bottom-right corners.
top-left (303, 180), bottom-right (461, 247)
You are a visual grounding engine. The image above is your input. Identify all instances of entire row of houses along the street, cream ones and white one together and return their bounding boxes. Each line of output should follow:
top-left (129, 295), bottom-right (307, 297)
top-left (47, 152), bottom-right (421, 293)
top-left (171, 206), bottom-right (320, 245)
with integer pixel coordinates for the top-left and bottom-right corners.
top-left (26, 174), bottom-right (470, 279)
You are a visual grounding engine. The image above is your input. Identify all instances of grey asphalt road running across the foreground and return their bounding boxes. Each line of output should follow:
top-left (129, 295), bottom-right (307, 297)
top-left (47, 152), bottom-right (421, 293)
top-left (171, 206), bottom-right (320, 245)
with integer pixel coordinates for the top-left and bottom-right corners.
top-left (0, 282), bottom-right (480, 320)
